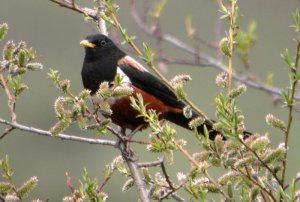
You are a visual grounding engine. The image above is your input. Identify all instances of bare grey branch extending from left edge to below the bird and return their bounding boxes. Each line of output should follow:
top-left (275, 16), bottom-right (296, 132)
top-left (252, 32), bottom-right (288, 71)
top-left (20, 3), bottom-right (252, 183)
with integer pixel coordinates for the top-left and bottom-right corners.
top-left (0, 118), bottom-right (117, 146)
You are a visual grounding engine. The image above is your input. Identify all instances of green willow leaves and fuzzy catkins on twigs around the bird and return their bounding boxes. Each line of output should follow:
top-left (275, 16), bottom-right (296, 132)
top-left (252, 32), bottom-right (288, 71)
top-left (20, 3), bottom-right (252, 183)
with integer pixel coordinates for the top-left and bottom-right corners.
top-left (0, 0), bottom-right (300, 202)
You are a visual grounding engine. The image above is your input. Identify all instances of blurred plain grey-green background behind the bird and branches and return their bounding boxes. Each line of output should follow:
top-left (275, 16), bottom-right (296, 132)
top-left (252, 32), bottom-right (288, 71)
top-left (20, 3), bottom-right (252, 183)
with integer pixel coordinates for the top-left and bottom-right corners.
top-left (0, 0), bottom-right (300, 201)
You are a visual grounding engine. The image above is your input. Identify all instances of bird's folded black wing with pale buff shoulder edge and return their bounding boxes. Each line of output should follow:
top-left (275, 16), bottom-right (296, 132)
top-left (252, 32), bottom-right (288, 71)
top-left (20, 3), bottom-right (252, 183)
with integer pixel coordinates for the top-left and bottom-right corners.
top-left (118, 56), bottom-right (185, 108)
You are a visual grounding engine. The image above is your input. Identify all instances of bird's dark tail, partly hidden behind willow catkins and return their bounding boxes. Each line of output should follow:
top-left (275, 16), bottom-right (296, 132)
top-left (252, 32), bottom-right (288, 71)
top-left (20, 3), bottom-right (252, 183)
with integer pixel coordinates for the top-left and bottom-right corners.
top-left (165, 112), bottom-right (252, 140)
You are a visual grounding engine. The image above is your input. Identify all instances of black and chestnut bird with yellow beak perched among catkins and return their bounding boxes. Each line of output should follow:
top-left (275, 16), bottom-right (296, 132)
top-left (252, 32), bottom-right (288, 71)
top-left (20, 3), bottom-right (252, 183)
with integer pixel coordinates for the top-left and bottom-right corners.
top-left (80, 34), bottom-right (251, 140)
